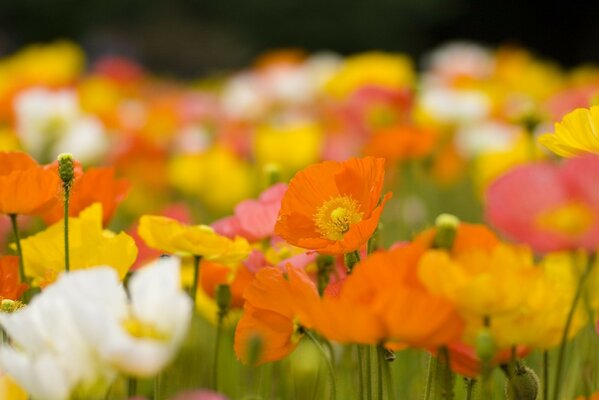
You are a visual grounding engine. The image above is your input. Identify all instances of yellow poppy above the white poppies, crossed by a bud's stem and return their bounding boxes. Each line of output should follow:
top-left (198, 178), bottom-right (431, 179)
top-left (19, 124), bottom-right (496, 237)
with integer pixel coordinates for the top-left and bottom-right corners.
top-left (13, 203), bottom-right (137, 285)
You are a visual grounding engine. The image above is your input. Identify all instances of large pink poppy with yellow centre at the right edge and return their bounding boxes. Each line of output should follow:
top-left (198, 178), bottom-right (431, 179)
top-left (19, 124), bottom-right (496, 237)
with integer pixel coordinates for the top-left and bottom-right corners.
top-left (485, 154), bottom-right (599, 253)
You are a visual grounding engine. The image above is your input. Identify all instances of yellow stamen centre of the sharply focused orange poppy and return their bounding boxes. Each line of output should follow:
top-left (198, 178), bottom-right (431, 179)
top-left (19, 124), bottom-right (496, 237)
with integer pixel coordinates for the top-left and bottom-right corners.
top-left (314, 195), bottom-right (363, 240)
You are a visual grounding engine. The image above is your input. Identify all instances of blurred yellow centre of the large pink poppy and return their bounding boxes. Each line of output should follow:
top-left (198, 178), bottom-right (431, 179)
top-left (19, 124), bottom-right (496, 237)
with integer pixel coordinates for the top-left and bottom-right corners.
top-left (537, 203), bottom-right (595, 236)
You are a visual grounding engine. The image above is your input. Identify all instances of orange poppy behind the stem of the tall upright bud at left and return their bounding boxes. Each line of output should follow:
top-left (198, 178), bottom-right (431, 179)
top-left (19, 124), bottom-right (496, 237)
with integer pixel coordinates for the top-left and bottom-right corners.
top-left (42, 164), bottom-right (130, 225)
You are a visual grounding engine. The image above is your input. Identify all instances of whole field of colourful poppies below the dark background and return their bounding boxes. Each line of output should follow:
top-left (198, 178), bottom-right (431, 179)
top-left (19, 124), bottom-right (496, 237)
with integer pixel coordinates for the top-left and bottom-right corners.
top-left (0, 43), bottom-right (599, 400)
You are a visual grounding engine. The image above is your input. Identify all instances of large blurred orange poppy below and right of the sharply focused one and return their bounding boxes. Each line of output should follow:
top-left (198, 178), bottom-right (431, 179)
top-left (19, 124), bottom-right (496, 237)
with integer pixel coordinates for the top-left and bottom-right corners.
top-left (338, 244), bottom-right (464, 348)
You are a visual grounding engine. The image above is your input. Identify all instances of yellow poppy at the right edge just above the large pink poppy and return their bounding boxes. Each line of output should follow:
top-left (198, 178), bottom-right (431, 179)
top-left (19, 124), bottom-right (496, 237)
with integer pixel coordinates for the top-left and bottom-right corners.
top-left (539, 106), bottom-right (599, 157)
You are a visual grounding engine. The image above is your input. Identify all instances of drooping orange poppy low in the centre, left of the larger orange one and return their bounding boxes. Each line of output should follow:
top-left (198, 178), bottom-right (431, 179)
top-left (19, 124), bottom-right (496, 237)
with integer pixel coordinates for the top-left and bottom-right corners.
top-left (234, 267), bottom-right (318, 364)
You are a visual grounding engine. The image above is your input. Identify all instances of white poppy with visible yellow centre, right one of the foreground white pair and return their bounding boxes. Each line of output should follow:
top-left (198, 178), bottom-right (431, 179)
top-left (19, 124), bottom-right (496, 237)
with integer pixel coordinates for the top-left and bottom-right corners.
top-left (72, 257), bottom-right (192, 377)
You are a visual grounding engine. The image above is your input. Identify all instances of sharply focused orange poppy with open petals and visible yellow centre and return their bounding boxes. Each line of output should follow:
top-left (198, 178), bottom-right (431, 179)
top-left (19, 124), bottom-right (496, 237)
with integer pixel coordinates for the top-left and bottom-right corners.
top-left (275, 157), bottom-right (391, 254)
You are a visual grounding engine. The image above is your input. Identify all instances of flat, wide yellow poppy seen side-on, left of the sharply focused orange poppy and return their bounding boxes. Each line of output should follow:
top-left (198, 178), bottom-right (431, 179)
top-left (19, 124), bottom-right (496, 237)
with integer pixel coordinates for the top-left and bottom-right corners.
top-left (138, 215), bottom-right (250, 265)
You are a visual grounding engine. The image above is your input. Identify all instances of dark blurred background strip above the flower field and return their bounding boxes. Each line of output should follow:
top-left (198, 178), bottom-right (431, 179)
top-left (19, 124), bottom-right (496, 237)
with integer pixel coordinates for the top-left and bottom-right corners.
top-left (0, 0), bottom-right (599, 76)
